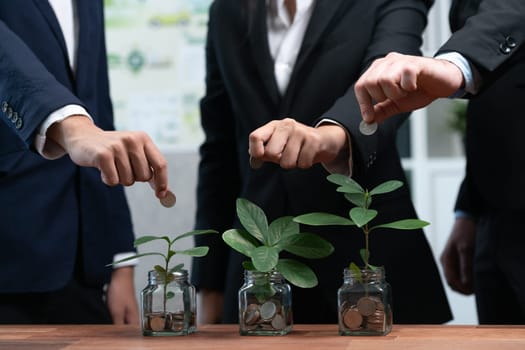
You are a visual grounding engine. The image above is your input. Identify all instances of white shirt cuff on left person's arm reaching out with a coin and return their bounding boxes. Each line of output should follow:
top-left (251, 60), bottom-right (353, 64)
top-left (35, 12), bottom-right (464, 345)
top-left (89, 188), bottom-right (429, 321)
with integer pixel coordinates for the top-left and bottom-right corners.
top-left (35, 105), bottom-right (93, 160)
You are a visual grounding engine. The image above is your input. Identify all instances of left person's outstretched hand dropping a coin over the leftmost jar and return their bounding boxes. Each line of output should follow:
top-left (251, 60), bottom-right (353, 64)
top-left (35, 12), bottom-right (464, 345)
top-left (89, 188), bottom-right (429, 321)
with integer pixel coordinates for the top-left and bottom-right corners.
top-left (47, 115), bottom-right (168, 198)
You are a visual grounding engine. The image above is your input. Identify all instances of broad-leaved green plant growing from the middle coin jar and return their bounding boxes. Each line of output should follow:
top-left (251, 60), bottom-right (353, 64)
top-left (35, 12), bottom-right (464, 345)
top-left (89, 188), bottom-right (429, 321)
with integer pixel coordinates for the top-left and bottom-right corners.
top-left (222, 198), bottom-right (334, 288)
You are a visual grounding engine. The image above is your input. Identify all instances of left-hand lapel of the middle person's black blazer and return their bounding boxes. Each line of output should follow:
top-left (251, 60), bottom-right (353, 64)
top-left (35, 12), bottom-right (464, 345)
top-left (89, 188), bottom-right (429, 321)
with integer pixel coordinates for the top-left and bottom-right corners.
top-left (249, 0), bottom-right (280, 104)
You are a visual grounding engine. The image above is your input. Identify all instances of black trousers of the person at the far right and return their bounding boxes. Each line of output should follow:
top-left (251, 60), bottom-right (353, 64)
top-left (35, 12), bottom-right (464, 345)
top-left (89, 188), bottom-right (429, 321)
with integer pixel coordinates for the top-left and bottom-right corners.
top-left (474, 211), bottom-right (525, 324)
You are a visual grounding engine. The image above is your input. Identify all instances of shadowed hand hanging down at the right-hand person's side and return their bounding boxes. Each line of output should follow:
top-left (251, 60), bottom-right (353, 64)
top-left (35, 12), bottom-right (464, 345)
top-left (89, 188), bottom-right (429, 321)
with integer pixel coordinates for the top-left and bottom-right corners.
top-left (440, 218), bottom-right (476, 295)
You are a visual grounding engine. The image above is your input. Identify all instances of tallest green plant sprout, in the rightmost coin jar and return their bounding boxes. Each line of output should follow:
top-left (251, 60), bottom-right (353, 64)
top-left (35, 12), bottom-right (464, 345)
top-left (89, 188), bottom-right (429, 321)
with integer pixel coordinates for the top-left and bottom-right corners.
top-left (294, 174), bottom-right (429, 275)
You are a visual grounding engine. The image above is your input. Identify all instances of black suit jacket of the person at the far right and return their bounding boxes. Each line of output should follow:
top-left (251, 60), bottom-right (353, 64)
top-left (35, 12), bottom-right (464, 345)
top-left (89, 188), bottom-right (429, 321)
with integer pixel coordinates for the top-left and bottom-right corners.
top-left (440, 0), bottom-right (525, 215)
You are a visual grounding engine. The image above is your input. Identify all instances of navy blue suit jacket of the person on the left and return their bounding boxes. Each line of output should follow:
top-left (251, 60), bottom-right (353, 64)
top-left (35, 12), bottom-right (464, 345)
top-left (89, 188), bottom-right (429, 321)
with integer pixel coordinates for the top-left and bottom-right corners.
top-left (0, 0), bottom-right (133, 293)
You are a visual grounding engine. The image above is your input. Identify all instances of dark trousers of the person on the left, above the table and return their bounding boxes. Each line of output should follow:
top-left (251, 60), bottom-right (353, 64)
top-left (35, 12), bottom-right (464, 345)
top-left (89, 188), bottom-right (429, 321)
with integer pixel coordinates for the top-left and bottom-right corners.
top-left (0, 279), bottom-right (112, 324)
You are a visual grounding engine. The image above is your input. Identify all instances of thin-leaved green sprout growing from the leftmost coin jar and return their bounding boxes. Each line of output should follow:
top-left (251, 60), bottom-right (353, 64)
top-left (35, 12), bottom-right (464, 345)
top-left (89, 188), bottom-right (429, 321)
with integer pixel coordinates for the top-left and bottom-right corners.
top-left (107, 230), bottom-right (218, 313)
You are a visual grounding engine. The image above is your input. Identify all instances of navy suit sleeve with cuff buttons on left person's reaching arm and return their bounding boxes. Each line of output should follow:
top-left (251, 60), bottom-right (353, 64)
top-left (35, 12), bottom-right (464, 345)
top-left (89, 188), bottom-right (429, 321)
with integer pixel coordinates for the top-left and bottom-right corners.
top-left (0, 21), bottom-right (83, 159)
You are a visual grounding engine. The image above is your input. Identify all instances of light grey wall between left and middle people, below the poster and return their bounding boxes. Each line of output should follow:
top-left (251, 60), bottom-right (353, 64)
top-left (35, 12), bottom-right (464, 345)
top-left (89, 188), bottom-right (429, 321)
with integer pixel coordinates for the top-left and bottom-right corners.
top-left (126, 151), bottom-right (198, 300)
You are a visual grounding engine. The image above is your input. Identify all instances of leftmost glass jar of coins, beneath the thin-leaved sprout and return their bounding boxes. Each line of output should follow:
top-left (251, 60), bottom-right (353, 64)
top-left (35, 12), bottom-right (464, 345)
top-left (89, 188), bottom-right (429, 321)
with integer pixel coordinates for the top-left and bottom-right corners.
top-left (140, 270), bottom-right (196, 336)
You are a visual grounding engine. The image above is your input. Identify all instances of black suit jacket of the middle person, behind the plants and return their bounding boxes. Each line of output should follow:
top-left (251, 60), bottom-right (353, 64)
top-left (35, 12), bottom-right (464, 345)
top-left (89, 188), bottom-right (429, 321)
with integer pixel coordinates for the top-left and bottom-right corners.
top-left (192, 0), bottom-right (451, 323)
